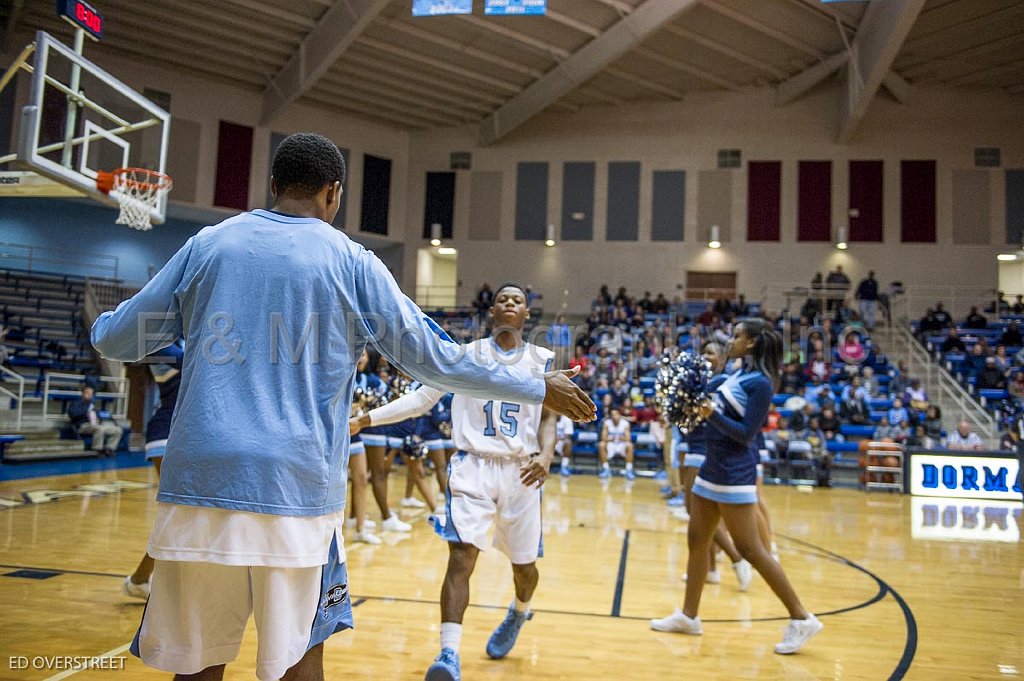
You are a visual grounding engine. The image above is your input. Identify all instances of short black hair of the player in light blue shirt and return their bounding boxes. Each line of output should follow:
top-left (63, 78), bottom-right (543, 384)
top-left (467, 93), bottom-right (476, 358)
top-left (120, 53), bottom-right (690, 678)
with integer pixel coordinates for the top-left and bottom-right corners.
top-left (271, 132), bottom-right (345, 197)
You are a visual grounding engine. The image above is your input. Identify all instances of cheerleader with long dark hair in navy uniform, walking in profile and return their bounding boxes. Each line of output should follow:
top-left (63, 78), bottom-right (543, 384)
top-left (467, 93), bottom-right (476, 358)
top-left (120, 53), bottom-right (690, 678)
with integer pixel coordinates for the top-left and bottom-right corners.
top-left (650, 320), bottom-right (822, 654)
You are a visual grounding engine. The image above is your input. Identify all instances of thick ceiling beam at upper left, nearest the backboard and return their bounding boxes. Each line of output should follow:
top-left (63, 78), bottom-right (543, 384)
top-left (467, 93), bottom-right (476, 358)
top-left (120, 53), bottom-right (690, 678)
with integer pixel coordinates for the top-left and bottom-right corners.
top-left (262, 0), bottom-right (388, 125)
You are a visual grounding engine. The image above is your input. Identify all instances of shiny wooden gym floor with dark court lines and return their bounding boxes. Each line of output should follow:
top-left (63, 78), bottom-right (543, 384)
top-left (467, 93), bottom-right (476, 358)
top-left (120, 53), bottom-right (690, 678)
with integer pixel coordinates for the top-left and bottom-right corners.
top-left (0, 468), bottom-right (1024, 681)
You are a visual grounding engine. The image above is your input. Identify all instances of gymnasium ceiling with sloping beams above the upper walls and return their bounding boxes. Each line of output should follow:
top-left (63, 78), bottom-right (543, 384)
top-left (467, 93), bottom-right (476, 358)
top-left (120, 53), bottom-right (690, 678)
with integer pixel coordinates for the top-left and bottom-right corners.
top-left (0, 0), bottom-right (1024, 143)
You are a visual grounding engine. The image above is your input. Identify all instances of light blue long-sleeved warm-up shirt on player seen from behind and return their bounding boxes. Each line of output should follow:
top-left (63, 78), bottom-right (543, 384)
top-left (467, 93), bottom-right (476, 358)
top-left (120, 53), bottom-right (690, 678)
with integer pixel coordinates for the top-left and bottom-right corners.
top-left (92, 210), bottom-right (545, 515)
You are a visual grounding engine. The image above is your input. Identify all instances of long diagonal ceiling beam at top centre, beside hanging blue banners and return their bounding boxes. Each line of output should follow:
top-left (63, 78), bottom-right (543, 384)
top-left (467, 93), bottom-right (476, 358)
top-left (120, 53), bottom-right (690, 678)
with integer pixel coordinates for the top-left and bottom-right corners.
top-left (479, 0), bottom-right (697, 145)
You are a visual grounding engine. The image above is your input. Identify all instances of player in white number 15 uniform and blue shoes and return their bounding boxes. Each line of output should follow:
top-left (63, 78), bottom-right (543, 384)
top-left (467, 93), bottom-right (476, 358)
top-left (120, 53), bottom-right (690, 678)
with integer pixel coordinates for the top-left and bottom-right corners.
top-left (352, 284), bottom-right (571, 681)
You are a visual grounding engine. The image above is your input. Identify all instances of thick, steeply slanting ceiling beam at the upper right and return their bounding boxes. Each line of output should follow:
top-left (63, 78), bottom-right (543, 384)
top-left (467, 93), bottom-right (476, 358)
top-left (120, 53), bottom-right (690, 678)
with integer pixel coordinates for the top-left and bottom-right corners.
top-left (837, 0), bottom-right (925, 143)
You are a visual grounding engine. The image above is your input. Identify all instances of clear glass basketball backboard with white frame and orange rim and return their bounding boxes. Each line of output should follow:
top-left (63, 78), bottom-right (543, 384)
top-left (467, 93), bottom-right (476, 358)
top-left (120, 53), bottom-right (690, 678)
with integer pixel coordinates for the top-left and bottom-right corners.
top-left (0, 31), bottom-right (171, 223)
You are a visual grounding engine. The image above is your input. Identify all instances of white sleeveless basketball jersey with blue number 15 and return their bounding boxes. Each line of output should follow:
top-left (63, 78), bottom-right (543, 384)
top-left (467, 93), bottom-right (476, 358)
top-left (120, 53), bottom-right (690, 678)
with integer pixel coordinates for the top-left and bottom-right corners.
top-left (452, 337), bottom-right (555, 457)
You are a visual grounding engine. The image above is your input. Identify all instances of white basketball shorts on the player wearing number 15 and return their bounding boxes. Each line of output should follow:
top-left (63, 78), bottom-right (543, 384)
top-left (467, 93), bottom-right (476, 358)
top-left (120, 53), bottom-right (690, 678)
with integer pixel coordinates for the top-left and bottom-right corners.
top-left (434, 452), bottom-right (544, 565)
